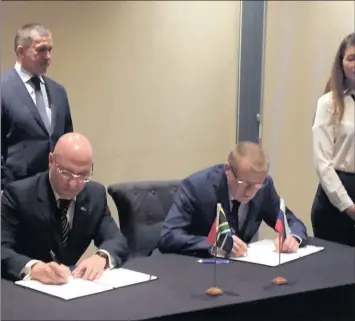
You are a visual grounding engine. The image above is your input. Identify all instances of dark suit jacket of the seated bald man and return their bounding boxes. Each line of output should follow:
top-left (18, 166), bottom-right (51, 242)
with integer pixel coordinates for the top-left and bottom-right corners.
top-left (1, 171), bottom-right (128, 279)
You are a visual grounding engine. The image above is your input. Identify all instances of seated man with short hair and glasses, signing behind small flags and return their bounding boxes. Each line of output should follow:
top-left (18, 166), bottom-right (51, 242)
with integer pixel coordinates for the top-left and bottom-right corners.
top-left (158, 142), bottom-right (307, 256)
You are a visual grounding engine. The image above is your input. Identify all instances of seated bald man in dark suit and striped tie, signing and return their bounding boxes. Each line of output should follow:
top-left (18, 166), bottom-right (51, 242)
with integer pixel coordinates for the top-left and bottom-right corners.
top-left (1, 133), bottom-right (128, 284)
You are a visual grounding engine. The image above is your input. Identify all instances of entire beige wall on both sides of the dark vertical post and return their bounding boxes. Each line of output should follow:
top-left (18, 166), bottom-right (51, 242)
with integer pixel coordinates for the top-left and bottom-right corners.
top-left (1, 1), bottom-right (354, 246)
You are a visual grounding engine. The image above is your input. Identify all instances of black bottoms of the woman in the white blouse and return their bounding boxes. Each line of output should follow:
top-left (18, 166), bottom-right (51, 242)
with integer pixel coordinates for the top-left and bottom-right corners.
top-left (311, 171), bottom-right (355, 246)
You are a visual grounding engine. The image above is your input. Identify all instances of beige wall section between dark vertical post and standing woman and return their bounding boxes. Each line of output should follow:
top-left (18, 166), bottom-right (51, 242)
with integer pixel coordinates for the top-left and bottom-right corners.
top-left (261, 1), bottom-right (355, 237)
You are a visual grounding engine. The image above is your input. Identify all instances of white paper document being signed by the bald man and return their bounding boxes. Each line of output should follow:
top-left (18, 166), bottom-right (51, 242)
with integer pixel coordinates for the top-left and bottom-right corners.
top-left (15, 268), bottom-right (157, 300)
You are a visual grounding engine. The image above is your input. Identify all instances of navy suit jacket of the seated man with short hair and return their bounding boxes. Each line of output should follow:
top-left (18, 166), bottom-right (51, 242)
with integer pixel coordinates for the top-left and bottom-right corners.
top-left (158, 165), bottom-right (307, 256)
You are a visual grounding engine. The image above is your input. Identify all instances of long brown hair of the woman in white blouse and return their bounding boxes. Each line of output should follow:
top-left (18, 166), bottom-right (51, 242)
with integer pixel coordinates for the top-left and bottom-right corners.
top-left (324, 32), bottom-right (355, 122)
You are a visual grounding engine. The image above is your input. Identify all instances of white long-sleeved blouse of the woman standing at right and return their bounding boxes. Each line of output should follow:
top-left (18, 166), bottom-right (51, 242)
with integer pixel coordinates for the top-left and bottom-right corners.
top-left (312, 92), bottom-right (355, 212)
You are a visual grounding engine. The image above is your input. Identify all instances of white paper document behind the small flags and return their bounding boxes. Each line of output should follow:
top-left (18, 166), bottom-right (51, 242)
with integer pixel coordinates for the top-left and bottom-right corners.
top-left (217, 240), bottom-right (324, 266)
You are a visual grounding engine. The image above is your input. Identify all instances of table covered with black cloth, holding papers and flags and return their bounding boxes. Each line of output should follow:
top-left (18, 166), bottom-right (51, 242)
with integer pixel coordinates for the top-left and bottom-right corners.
top-left (1, 239), bottom-right (355, 321)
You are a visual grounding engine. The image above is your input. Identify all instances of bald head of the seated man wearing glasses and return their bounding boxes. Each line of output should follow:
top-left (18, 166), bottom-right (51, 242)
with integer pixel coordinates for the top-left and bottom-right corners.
top-left (49, 133), bottom-right (93, 199)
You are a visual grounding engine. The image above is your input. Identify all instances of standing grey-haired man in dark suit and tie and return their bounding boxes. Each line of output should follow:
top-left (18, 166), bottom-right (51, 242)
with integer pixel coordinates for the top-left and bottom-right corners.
top-left (1, 24), bottom-right (73, 190)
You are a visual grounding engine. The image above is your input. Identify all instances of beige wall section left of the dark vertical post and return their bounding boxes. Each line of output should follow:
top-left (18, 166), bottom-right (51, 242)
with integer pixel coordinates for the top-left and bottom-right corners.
top-left (1, 1), bottom-right (240, 255)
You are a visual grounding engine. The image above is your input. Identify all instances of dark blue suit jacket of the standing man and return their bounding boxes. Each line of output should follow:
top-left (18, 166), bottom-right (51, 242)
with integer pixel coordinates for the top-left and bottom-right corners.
top-left (1, 68), bottom-right (73, 189)
